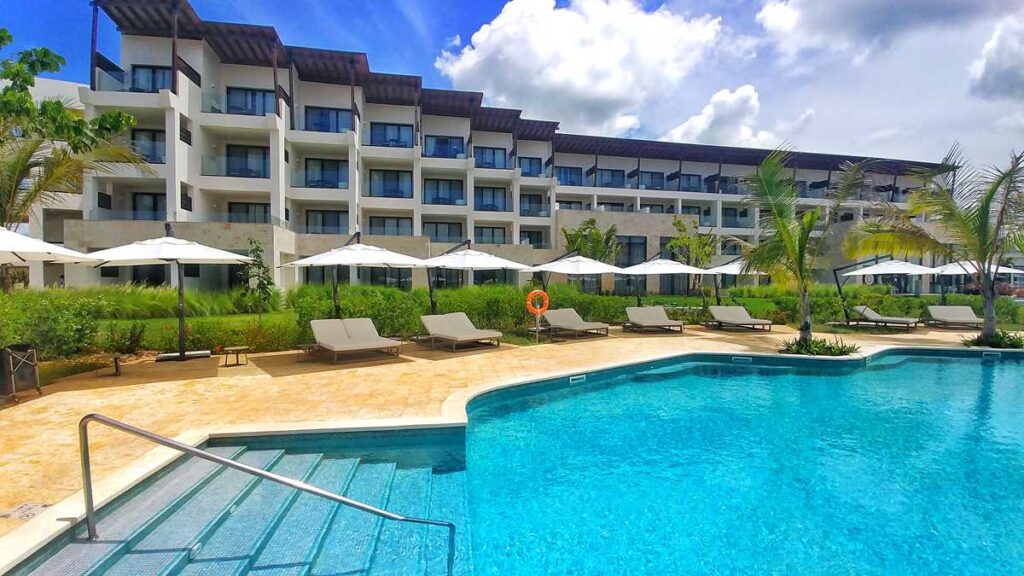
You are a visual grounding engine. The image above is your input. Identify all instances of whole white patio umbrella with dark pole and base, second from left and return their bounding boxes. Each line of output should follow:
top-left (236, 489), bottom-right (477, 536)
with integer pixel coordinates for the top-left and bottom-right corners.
top-left (89, 222), bottom-right (252, 360)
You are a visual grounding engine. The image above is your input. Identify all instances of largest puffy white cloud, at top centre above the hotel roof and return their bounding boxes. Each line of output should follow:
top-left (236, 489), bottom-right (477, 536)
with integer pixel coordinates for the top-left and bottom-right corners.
top-left (434, 0), bottom-right (722, 135)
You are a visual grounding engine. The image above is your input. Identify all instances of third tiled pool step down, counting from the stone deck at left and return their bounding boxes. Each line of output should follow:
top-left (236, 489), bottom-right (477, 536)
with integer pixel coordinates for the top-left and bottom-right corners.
top-left (174, 454), bottom-right (322, 576)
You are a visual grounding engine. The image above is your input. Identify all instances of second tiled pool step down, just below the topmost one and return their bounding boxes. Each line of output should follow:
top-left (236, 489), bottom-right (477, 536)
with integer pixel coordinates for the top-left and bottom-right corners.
top-left (100, 450), bottom-right (284, 576)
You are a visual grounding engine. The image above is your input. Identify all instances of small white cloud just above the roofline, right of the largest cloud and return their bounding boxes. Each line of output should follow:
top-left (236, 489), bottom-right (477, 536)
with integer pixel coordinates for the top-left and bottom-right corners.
top-left (660, 84), bottom-right (815, 148)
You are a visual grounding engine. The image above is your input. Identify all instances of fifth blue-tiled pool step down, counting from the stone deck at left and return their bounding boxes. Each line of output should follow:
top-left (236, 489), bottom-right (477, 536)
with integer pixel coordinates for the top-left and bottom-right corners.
top-left (310, 462), bottom-right (395, 576)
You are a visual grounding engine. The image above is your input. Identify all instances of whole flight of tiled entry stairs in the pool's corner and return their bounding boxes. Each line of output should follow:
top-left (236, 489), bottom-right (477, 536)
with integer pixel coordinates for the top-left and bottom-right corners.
top-left (14, 416), bottom-right (471, 576)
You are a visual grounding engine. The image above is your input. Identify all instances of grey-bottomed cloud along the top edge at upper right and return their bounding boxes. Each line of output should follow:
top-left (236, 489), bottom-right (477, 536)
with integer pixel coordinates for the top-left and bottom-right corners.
top-left (756, 0), bottom-right (1007, 64)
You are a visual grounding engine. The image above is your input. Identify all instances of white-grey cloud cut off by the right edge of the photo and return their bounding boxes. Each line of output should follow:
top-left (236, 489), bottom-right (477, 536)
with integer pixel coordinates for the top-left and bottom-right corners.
top-left (971, 12), bottom-right (1024, 100)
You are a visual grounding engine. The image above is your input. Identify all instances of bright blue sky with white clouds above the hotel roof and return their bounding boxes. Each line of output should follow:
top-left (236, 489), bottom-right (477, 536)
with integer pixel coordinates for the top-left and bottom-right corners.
top-left (0, 0), bottom-right (1024, 164)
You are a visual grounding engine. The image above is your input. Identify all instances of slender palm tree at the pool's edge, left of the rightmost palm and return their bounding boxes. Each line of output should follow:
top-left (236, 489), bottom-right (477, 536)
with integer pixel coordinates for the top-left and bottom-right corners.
top-left (743, 150), bottom-right (868, 342)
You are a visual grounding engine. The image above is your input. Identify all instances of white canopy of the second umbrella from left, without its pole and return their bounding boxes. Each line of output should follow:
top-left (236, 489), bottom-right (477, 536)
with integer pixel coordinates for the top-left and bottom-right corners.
top-left (89, 236), bottom-right (252, 266)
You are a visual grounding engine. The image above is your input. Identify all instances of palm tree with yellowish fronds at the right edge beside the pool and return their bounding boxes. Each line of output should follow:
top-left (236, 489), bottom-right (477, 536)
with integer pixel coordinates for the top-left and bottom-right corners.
top-left (845, 147), bottom-right (1024, 342)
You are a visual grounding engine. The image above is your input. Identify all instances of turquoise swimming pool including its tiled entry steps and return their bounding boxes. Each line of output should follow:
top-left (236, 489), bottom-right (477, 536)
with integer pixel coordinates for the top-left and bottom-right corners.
top-left (9, 352), bottom-right (1024, 574)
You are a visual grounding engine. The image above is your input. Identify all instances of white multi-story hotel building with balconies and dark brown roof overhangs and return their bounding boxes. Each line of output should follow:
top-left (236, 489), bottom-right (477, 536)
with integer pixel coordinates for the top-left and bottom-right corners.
top-left (25, 0), bottom-right (937, 291)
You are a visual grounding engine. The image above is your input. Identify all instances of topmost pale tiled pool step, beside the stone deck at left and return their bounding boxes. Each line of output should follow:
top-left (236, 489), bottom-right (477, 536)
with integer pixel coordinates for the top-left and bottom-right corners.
top-left (18, 447), bottom-right (245, 576)
